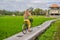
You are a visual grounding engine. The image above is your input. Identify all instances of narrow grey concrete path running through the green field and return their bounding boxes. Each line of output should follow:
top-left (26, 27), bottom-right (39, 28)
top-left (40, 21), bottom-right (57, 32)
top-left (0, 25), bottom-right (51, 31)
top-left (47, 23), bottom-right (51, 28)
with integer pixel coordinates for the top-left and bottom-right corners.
top-left (4, 20), bottom-right (55, 40)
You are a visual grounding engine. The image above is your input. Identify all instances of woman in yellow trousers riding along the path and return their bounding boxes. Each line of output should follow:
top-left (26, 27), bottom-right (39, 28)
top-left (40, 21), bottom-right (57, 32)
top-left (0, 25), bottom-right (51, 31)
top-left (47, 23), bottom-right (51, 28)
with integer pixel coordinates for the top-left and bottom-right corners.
top-left (24, 9), bottom-right (32, 32)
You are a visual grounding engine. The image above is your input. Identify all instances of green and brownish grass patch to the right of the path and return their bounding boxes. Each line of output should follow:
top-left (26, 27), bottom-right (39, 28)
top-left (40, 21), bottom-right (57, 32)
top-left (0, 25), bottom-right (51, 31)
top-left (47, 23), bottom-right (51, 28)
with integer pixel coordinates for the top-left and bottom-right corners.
top-left (38, 20), bottom-right (60, 40)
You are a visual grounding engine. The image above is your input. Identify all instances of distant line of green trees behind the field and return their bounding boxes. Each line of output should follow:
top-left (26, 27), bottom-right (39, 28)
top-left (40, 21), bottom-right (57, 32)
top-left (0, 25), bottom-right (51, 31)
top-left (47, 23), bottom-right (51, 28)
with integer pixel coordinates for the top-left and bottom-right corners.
top-left (0, 8), bottom-right (46, 15)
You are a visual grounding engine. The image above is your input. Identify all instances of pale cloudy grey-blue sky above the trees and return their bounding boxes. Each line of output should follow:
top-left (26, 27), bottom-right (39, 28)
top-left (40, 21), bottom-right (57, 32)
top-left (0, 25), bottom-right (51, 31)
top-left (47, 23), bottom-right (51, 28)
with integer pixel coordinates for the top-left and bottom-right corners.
top-left (0, 0), bottom-right (60, 11)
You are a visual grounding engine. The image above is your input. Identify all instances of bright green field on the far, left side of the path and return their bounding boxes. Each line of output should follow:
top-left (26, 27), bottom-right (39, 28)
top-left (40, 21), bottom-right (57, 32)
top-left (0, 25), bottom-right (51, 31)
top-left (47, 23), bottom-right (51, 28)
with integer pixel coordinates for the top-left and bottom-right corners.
top-left (0, 16), bottom-right (53, 40)
